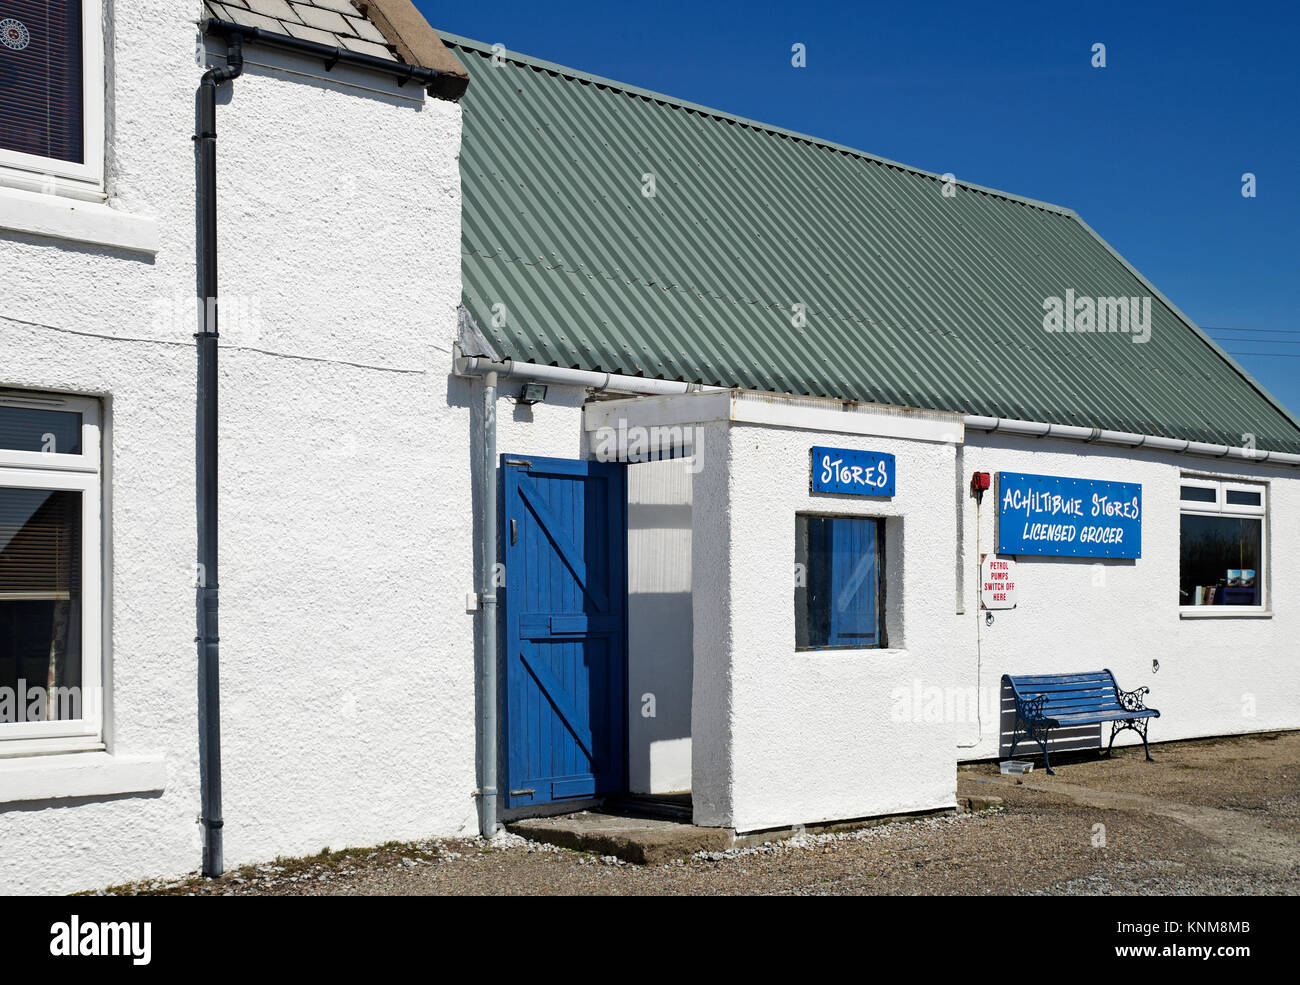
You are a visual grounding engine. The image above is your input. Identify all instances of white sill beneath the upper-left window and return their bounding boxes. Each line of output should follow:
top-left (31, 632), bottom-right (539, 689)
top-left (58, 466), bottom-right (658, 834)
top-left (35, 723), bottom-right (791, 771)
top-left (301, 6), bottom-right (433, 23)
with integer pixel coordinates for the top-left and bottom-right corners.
top-left (0, 187), bottom-right (159, 256)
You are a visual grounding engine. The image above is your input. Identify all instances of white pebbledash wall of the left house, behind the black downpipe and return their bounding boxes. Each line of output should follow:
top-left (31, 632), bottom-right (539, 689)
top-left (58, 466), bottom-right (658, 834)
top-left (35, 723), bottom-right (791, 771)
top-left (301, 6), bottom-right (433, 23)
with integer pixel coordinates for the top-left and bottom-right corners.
top-left (0, 0), bottom-right (476, 893)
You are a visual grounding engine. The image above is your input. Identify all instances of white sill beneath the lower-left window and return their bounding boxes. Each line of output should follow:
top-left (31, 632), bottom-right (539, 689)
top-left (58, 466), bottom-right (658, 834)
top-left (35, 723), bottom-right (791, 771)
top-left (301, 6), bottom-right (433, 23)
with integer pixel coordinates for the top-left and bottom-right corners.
top-left (0, 752), bottom-right (166, 804)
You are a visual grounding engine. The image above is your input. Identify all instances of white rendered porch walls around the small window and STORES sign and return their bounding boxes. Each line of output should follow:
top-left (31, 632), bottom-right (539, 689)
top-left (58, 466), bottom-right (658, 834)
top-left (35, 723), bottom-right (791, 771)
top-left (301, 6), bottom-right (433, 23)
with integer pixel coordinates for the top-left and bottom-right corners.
top-left (693, 424), bottom-right (963, 830)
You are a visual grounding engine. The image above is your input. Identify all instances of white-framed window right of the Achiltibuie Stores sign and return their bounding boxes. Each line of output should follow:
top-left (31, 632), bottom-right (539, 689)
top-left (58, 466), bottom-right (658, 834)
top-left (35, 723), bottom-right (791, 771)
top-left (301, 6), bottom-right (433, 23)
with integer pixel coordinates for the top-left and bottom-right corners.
top-left (1178, 477), bottom-right (1266, 607)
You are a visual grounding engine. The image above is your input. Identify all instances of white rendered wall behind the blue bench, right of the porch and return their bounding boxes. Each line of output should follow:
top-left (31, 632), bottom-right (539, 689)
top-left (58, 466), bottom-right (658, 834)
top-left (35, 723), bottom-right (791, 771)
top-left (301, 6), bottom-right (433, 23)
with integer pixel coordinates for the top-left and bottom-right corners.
top-left (958, 430), bottom-right (1300, 759)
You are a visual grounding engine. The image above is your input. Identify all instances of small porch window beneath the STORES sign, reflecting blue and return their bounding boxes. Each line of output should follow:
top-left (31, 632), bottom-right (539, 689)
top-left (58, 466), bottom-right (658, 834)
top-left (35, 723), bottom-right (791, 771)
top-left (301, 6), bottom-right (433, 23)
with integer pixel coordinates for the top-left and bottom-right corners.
top-left (794, 515), bottom-right (885, 650)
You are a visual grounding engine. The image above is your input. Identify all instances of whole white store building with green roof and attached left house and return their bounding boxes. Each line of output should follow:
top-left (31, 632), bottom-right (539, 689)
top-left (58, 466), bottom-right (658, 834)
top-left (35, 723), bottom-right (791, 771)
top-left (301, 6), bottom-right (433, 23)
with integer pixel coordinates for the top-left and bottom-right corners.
top-left (0, 0), bottom-right (1300, 891)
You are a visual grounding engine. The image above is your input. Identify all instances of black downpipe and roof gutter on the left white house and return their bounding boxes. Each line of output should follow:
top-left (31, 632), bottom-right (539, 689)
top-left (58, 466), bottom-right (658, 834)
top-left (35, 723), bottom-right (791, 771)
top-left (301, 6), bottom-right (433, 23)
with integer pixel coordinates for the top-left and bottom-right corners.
top-left (194, 18), bottom-right (470, 877)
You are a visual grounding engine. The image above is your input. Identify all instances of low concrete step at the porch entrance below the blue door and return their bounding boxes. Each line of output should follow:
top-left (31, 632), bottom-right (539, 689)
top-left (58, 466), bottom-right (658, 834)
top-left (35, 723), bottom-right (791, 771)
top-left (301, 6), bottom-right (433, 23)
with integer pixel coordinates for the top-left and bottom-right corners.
top-left (506, 811), bottom-right (733, 865)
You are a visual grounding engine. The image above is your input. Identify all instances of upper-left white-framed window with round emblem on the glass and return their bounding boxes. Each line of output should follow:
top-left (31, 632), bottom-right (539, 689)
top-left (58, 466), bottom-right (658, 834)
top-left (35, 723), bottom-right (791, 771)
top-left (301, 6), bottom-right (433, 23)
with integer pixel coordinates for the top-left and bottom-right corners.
top-left (0, 0), bottom-right (105, 192)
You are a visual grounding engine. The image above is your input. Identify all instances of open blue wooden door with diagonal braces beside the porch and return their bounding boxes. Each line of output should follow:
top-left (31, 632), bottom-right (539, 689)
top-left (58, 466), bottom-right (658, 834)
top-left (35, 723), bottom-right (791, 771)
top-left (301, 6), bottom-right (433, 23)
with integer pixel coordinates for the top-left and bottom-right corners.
top-left (502, 455), bottom-right (628, 807)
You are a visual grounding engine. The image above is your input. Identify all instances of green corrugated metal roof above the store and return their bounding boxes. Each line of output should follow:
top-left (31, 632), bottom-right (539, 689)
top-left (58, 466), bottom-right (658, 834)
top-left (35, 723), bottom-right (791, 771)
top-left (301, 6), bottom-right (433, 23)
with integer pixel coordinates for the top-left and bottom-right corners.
top-left (445, 35), bottom-right (1300, 452)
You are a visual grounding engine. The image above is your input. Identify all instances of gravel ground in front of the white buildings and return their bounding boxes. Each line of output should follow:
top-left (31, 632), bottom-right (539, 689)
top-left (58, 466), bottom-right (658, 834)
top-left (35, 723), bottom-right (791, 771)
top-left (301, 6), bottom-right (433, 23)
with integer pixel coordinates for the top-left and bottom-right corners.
top-left (100, 733), bottom-right (1300, 895)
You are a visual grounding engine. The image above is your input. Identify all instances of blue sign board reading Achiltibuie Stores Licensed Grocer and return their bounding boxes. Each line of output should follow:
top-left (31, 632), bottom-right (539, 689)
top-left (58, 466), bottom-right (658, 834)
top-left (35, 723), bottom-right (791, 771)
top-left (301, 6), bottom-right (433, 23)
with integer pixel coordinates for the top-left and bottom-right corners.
top-left (997, 472), bottom-right (1141, 557)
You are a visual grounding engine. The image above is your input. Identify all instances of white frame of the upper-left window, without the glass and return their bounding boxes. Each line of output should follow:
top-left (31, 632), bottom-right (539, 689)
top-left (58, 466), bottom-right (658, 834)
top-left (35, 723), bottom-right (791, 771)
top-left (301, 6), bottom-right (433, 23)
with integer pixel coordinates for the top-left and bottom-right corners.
top-left (0, 0), bottom-right (108, 195)
